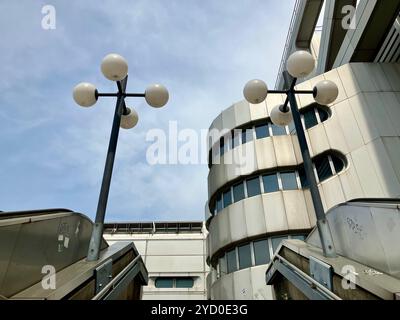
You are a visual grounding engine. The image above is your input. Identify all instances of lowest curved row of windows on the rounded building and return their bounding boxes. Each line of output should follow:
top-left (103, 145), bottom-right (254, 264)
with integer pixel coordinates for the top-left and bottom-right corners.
top-left (214, 235), bottom-right (306, 278)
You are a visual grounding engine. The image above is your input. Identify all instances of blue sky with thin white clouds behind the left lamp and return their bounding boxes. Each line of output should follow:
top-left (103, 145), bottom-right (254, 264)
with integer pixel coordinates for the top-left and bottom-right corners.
top-left (0, 0), bottom-right (294, 221)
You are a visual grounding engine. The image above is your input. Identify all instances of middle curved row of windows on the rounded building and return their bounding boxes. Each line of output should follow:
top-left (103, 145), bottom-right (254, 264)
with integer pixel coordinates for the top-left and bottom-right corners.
top-left (210, 154), bottom-right (345, 215)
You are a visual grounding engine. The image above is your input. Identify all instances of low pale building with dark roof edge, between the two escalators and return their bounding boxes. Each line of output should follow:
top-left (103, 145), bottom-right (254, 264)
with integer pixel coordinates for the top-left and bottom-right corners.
top-left (104, 222), bottom-right (209, 300)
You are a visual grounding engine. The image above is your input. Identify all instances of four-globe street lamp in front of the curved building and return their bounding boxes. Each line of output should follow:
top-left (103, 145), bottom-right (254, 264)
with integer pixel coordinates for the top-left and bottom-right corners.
top-left (243, 51), bottom-right (339, 257)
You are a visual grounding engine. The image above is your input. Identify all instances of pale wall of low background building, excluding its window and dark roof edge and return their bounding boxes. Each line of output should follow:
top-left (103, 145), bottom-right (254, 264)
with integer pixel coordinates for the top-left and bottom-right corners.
top-left (104, 230), bottom-right (209, 300)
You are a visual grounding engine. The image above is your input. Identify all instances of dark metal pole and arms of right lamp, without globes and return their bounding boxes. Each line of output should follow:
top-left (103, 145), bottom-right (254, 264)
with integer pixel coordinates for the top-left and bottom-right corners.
top-left (268, 71), bottom-right (337, 258)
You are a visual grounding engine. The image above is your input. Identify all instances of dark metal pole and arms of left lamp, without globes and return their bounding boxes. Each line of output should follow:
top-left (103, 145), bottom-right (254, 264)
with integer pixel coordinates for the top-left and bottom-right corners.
top-left (87, 76), bottom-right (145, 261)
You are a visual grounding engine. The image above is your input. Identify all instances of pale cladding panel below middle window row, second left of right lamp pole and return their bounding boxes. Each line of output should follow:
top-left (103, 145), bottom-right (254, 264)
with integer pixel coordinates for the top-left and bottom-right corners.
top-left (262, 192), bottom-right (288, 232)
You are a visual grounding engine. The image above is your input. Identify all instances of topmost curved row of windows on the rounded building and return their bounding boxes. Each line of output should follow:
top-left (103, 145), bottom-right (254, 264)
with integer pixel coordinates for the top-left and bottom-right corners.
top-left (209, 105), bottom-right (329, 167)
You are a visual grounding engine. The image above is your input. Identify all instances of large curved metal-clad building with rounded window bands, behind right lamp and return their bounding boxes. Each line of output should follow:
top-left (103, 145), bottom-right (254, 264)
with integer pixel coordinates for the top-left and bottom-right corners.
top-left (206, 0), bottom-right (400, 299)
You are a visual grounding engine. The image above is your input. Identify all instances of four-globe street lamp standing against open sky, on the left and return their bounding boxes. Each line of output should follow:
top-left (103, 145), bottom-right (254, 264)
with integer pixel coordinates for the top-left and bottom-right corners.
top-left (73, 53), bottom-right (169, 261)
